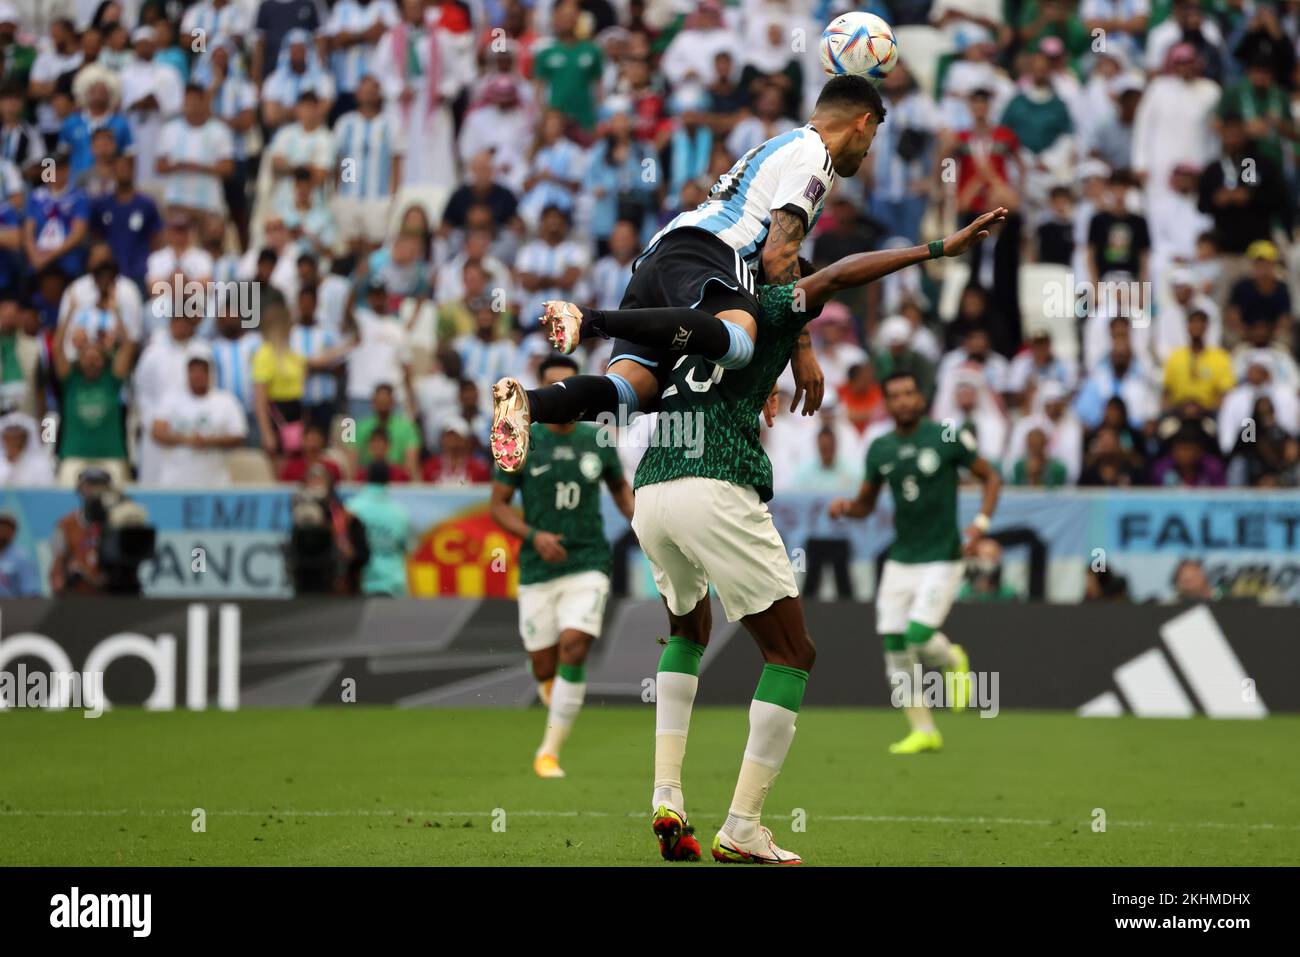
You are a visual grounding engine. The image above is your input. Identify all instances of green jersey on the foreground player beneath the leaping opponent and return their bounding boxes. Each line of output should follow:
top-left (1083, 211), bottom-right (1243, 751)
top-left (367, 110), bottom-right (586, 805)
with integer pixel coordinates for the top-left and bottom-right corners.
top-left (636, 282), bottom-right (813, 502)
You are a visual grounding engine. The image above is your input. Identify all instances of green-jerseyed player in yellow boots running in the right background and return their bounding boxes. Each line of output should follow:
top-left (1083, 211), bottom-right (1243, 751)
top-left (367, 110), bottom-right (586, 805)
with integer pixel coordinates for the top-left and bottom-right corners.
top-left (829, 372), bottom-right (1002, 754)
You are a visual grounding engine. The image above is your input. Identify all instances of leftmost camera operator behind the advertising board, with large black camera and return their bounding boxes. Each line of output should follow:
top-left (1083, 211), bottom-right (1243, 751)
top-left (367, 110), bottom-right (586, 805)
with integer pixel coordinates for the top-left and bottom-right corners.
top-left (49, 468), bottom-right (156, 596)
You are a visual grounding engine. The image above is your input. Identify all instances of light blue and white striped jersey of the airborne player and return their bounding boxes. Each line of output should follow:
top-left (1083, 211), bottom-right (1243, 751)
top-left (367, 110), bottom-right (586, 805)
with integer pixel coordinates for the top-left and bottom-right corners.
top-left (641, 126), bottom-right (835, 272)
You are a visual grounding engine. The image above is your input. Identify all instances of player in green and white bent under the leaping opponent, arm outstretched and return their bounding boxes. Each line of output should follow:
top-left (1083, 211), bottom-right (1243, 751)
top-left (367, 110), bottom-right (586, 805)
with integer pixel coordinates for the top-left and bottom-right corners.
top-left (535, 208), bottom-right (1006, 863)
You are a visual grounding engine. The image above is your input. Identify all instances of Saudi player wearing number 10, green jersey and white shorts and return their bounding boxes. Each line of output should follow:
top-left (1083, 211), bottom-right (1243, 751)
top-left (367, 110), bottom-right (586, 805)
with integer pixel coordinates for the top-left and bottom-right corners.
top-left (491, 356), bottom-right (633, 778)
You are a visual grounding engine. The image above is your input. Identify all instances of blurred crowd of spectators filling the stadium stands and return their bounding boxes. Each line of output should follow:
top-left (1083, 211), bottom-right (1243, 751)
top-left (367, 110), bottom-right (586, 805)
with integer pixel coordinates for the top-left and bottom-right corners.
top-left (0, 0), bottom-right (1300, 501)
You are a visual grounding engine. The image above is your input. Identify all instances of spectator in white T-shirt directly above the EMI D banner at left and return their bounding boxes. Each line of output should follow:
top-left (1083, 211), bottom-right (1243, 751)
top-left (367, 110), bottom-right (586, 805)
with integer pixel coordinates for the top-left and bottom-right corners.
top-left (150, 346), bottom-right (248, 488)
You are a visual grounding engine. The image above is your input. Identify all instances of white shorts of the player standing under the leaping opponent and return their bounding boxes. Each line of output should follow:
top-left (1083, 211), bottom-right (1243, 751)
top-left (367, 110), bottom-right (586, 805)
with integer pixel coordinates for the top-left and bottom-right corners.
top-left (632, 477), bottom-right (800, 622)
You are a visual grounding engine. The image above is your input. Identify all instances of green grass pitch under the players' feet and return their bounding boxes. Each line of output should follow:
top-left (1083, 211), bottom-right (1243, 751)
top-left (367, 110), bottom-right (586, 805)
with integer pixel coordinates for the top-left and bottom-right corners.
top-left (0, 706), bottom-right (1300, 867)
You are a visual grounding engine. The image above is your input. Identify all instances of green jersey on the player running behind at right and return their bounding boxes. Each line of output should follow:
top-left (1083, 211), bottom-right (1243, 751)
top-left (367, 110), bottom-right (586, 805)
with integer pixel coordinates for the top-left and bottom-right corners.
top-left (867, 419), bottom-right (978, 564)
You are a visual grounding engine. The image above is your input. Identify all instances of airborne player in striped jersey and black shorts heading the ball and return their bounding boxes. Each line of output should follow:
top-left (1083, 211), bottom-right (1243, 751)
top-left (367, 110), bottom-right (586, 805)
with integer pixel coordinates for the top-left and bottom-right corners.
top-left (491, 75), bottom-right (885, 472)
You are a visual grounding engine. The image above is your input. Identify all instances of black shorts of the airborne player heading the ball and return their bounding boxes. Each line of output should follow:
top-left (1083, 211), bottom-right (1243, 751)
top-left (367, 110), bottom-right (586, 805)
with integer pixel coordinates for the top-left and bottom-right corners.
top-left (610, 226), bottom-right (759, 391)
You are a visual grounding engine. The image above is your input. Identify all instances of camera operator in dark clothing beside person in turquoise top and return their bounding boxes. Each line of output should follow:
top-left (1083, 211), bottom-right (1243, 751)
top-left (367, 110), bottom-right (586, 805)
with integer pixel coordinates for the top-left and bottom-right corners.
top-left (285, 463), bottom-right (371, 596)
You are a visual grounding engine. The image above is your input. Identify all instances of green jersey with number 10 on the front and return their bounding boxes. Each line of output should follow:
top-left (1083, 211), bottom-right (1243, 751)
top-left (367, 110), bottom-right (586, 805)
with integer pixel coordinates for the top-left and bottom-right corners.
top-left (497, 423), bottom-right (623, 585)
